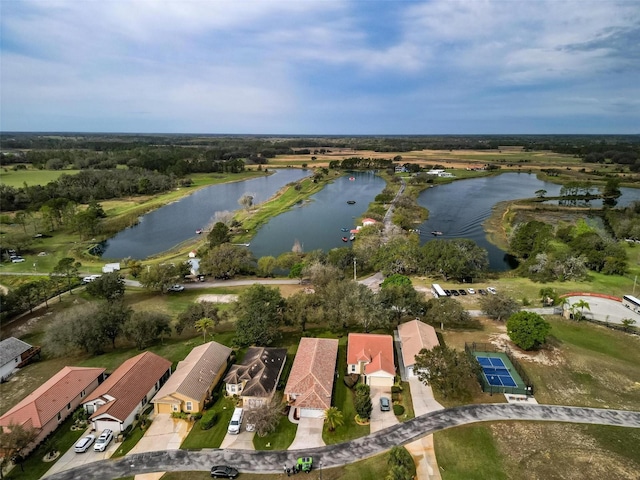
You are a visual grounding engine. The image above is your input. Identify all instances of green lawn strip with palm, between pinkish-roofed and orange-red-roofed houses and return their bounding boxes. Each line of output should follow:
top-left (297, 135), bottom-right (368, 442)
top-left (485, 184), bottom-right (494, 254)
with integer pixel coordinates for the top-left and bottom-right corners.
top-left (322, 337), bottom-right (370, 445)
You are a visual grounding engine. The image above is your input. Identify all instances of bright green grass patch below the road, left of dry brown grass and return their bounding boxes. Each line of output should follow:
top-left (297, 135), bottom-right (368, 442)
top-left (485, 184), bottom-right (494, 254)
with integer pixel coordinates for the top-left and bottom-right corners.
top-left (434, 425), bottom-right (508, 480)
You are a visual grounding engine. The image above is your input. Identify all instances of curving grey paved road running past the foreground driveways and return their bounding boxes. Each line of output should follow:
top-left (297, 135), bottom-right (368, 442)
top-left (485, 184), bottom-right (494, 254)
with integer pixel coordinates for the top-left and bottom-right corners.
top-left (48, 403), bottom-right (640, 480)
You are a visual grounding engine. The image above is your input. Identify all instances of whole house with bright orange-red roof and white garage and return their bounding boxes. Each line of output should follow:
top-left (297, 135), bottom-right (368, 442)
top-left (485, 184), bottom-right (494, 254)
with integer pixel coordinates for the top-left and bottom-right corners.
top-left (347, 333), bottom-right (396, 387)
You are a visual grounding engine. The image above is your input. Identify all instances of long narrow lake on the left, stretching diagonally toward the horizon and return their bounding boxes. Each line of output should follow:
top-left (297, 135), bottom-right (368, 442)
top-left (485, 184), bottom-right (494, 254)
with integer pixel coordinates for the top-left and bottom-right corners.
top-left (102, 168), bottom-right (311, 259)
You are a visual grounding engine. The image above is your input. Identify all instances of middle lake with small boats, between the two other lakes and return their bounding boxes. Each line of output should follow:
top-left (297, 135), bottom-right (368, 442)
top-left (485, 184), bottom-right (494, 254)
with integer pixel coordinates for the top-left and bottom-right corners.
top-left (250, 172), bottom-right (385, 258)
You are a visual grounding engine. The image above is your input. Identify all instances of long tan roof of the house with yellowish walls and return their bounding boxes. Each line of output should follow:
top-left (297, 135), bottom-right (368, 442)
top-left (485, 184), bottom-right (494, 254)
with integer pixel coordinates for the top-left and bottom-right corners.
top-left (152, 342), bottom-right (231, 401)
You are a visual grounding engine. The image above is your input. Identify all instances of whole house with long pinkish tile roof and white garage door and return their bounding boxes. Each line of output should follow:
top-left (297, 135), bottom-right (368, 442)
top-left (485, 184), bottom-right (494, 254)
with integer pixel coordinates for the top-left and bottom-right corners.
top-left (284, 338), bottom-right (338, 418)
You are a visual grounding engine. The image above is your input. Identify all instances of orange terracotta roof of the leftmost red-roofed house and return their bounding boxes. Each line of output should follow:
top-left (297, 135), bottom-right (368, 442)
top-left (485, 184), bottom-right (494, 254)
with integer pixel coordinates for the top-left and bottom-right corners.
top-left (0, 367), bottom-right (104, 428)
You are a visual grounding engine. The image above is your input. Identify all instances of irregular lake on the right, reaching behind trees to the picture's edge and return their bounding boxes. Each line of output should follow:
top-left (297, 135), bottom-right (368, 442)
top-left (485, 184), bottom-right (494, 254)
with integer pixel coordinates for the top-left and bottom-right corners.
top-left (418, 173), bottom-right (640, 271)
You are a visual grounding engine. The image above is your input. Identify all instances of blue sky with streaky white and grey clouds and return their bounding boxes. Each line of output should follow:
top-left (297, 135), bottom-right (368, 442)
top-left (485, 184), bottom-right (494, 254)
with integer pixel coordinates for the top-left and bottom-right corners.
top-left (0, 0), bottom-right (640, 134)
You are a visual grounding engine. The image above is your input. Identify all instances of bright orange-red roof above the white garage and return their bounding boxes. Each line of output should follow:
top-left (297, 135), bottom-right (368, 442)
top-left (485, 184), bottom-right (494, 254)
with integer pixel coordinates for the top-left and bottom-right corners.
top-left (347, 333), bottom-right (396, 375)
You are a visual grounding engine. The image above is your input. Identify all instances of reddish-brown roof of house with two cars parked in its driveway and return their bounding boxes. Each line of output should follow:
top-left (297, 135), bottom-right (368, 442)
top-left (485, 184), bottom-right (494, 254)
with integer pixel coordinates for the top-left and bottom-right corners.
top-left (83, 352), bottom-right (171, 422)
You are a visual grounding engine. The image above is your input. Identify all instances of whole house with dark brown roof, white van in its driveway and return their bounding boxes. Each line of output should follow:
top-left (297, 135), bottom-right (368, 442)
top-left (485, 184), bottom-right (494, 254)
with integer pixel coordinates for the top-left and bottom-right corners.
top-left (224, 347), bottom-right (287, 408)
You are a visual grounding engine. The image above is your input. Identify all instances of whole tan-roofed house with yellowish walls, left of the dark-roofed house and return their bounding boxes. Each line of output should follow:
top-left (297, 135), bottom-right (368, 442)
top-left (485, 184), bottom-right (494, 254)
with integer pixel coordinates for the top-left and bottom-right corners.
top-left (151, 342), bottom-right (231, 413)
